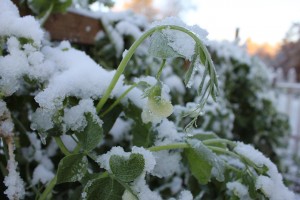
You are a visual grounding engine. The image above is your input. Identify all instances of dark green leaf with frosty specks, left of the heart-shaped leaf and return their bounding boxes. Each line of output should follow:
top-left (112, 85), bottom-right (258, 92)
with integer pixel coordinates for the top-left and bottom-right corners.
top-left (56, 153), bottom-right (88, 184)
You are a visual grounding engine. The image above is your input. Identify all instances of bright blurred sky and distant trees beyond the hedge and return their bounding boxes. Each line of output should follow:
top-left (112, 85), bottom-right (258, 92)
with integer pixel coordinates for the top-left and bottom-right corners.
top-left (108, 0), bottom-right (300, 82)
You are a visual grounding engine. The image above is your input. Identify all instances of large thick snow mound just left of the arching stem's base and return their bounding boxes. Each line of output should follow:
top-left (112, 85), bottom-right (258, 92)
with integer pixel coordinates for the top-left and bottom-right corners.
top-left (35, 45), bottom-right (122, 109)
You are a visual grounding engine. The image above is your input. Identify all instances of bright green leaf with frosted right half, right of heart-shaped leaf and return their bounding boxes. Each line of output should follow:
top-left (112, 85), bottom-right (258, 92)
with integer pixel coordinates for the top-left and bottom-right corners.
top-left (185, 139), bottom-right (225, 184)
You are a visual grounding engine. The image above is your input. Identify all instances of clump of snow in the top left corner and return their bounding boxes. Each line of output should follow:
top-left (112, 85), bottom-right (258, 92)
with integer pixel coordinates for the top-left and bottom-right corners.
top-left (0, 0), bottom-right (44, 45)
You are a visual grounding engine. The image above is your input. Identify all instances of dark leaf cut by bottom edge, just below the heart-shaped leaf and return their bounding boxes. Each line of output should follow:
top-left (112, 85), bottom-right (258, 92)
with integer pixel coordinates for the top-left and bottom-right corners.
top-left (81, 177), bottom-right (125, 200)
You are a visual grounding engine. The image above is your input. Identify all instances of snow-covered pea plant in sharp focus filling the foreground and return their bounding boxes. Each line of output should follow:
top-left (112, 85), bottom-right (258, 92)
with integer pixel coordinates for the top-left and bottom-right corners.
top-left (0, 0), bottom-right (295, 200)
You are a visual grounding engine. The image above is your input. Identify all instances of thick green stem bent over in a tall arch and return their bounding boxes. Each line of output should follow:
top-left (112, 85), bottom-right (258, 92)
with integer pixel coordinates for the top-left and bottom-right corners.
top-left (96, 25), bottom-right (213, 113)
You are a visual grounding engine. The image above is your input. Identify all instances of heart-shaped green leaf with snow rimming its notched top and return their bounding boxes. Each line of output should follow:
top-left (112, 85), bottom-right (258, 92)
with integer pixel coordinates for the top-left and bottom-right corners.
top-left (109, 153), bottom-right (145, 183)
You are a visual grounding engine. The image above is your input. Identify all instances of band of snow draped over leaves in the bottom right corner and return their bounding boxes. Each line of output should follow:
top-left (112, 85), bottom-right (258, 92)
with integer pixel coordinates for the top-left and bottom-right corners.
top-left (234, 142), bottom-right (295, 200)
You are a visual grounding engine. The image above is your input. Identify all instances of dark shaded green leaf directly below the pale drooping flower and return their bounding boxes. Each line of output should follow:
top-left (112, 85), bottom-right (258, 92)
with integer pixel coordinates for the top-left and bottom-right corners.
top-left (124, 102), bottom-right (155, 148)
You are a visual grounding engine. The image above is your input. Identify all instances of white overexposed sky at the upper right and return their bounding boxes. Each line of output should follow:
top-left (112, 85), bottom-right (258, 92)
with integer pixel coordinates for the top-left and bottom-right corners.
top-left (116, 0), bottom-right (300, 45)
